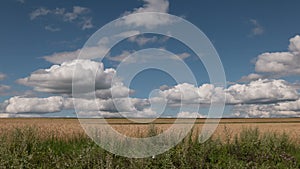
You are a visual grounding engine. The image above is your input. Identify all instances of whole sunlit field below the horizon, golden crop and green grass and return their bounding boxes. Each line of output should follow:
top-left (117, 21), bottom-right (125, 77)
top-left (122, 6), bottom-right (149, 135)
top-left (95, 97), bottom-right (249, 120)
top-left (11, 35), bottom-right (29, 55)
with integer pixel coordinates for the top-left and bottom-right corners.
top-left (0, 118), bottom-right (300, 168)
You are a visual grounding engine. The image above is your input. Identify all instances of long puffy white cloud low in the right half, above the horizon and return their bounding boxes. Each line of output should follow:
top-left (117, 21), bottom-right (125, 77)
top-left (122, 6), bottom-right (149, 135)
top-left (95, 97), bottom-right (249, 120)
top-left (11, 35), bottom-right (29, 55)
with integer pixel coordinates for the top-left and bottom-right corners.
top-left (153, 79), bottom-right (299, 106)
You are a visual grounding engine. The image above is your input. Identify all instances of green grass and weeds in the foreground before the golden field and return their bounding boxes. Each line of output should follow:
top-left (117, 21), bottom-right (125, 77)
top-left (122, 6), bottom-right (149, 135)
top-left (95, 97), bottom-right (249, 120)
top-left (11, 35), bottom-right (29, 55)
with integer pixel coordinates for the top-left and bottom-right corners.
top-left (0, 126), bottom-right (300, 169)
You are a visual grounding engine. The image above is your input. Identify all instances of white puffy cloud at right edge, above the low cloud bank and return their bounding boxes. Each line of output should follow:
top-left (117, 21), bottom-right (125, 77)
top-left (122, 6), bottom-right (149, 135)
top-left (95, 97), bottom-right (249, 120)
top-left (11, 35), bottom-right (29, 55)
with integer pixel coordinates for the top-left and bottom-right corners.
top-left (255, 35), bottom-right (300, 77)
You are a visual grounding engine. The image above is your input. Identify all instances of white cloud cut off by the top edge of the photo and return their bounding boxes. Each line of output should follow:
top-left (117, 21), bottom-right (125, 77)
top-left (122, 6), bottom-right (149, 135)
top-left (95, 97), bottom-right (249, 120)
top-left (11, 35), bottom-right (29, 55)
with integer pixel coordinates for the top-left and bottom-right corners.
top-left (118, 0), bottom-right (174, 29)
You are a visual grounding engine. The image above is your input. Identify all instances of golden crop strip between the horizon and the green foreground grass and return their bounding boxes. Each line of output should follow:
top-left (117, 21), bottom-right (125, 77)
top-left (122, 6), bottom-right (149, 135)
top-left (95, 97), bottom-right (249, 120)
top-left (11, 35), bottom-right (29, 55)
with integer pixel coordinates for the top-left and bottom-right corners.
top-left (0, 118), bottom-right (300, 143)
